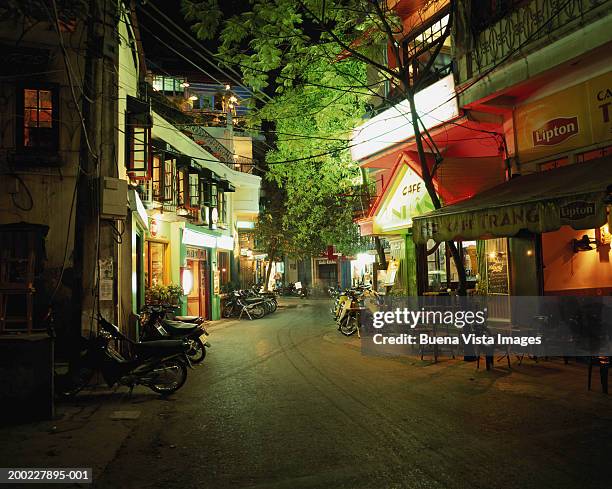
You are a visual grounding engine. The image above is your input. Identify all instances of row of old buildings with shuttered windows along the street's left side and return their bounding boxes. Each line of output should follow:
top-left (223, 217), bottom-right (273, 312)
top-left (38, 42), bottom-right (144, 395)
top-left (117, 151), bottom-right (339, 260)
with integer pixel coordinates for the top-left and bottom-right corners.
top-left (0, 2), bottom-right (260, 337)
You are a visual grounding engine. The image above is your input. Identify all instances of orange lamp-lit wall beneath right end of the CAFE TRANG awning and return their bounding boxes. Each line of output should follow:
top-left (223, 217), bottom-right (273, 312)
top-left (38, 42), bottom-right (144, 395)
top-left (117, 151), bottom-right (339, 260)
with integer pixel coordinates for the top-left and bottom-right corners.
top-left (542, 226), bottom-right (612, 293)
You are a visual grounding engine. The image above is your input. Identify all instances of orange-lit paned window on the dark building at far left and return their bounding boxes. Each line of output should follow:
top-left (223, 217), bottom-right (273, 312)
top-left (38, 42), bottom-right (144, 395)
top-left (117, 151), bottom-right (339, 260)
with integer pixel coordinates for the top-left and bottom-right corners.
top-left (16, 86), bottom-right (59, 151)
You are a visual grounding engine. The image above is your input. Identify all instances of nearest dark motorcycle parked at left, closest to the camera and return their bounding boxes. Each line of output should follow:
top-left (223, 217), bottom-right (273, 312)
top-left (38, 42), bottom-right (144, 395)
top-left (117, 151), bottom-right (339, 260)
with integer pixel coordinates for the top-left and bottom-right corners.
top-left (55, 317), bottom-right (190, 396)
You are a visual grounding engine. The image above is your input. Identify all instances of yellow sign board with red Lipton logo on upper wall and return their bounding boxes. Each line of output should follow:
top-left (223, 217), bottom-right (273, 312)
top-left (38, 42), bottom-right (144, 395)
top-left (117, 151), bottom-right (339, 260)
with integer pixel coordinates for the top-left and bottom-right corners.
top-left (516, 72), bottom-right (612, 161)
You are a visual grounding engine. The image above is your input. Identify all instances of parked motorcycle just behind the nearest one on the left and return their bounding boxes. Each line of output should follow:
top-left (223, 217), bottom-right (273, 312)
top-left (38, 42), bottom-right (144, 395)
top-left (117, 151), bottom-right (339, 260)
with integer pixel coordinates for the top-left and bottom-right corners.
top-left (139, 305), bottom-right (210, 364)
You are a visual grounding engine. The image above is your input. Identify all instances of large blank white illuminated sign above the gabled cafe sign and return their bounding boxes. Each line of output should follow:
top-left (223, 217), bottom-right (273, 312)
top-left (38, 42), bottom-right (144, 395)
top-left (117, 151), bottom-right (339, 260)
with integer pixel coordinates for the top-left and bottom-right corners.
top-left (351, 75), bottom-right (459, 161)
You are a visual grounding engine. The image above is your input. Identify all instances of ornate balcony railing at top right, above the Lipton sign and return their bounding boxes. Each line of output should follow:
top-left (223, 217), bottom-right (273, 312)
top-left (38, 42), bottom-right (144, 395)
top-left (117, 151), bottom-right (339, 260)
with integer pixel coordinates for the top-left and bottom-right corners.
top-left (462, 0), bottom-right (612, 82)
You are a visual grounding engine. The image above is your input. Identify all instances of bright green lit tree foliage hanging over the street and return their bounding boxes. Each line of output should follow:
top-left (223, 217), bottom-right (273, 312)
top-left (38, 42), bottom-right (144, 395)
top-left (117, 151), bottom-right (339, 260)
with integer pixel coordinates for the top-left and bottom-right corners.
top-left (184, 0), bottom-right (394, 255)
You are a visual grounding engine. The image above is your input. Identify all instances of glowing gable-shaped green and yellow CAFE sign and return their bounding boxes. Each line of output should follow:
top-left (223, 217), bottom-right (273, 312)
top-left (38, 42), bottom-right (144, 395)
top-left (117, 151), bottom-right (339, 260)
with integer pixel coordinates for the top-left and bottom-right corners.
top-left (372, 165), bottom-right (434, 234)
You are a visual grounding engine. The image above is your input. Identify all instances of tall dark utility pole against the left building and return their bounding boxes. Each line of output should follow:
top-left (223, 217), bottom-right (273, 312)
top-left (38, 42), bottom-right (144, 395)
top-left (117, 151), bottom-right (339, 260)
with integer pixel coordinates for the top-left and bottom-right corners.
top-left (72, 0), bottom-right (119, 340)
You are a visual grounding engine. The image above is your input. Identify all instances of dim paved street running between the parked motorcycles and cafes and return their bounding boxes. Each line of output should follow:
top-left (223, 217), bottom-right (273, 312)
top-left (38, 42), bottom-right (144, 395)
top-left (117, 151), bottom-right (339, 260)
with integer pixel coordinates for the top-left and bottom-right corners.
top-left (95, 300), bottom-right (612, 489)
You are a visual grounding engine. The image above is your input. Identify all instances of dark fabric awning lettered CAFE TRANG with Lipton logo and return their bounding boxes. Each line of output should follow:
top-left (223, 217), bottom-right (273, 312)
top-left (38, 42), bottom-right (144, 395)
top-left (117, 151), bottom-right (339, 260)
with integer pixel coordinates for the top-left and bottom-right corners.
top-left (412, 157), bottom-right (612, 244)
